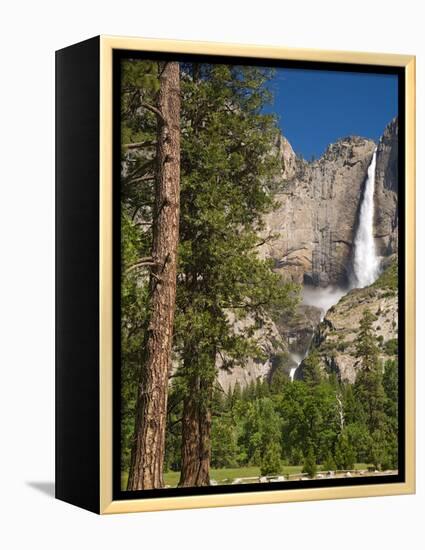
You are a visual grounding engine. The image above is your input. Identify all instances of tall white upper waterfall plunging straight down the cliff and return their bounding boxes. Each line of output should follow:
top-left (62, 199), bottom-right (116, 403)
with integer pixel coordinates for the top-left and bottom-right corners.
top-left (351, 149), bottom-right (379, 288)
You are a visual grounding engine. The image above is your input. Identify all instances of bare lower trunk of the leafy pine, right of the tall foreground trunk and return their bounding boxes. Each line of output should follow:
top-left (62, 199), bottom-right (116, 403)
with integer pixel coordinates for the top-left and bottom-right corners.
top-left (179, 377), bottom-right (212, 487)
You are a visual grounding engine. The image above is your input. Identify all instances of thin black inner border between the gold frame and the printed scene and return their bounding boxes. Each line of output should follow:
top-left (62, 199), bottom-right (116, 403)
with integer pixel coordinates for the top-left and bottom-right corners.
top-left (112, 49), bottom-right (406, 500)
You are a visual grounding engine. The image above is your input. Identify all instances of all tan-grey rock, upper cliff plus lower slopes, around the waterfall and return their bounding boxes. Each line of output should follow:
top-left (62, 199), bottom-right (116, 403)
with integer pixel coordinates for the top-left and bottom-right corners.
top-left (217, 119), bottom-right (398, 391)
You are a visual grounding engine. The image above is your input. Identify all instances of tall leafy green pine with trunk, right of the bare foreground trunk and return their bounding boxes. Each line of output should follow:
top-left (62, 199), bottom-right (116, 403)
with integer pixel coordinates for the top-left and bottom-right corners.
top-left (176, 63), bottom-right (295, 486)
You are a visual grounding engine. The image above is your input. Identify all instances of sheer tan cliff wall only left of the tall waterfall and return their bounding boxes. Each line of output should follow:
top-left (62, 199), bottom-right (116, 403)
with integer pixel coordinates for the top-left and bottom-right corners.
top-left (265, 137), bottom-right (375, 286)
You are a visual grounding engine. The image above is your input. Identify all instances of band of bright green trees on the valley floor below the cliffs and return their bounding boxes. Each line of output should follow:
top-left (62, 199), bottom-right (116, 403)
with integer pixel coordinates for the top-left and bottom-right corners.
top-left (161, 354), bottom-right (398, 475)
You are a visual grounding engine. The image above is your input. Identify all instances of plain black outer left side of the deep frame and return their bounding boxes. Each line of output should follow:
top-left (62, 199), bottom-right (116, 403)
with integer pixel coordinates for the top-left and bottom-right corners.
top-left (55, 37), bottom-right (100, 513)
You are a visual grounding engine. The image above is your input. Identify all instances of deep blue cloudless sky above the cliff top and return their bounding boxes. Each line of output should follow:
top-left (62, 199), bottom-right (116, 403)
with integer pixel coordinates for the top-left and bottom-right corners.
top-left (267, 69), bottom-right (397, 159)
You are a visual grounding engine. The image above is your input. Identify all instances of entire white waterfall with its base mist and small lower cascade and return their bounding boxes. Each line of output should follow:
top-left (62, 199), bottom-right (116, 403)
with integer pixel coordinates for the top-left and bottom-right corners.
top-left (289, 149), bottom-right (380, 380)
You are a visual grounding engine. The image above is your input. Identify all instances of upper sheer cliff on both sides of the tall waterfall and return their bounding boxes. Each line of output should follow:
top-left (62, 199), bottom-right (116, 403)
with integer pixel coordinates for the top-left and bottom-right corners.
top-left (262, 120), bottom-right (398, 287)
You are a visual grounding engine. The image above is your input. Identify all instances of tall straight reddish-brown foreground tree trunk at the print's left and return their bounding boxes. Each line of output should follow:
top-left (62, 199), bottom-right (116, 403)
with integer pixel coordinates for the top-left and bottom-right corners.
top-left (127, 62), bottom-right (180, 490)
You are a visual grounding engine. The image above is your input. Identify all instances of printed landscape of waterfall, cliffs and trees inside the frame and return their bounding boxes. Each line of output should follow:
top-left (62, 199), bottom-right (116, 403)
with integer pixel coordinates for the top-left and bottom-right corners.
top-left (114, 54), bottom-right (402, 494)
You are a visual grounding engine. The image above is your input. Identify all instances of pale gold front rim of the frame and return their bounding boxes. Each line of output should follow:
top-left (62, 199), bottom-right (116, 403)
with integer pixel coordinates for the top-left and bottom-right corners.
top-left (99, 36), bottom-right (415, 514)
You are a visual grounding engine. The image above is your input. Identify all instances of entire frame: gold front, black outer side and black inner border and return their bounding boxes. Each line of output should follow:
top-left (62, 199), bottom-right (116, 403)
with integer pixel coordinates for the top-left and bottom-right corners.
top-left (56, 36), bottom-right (415, 514)
